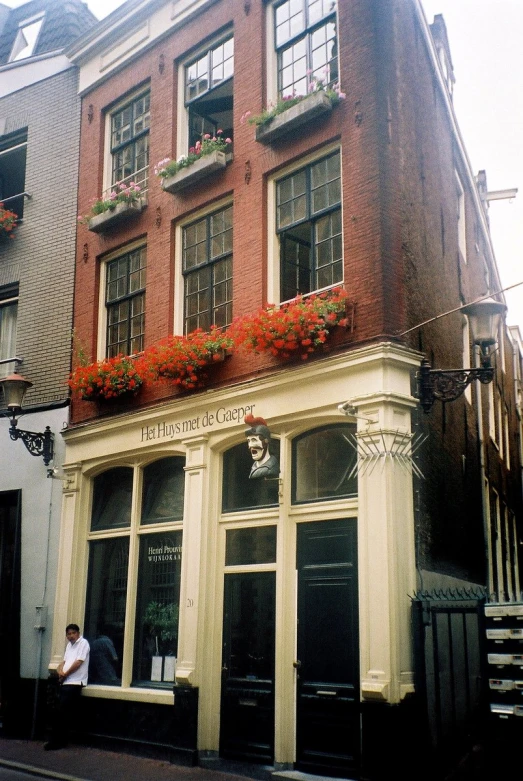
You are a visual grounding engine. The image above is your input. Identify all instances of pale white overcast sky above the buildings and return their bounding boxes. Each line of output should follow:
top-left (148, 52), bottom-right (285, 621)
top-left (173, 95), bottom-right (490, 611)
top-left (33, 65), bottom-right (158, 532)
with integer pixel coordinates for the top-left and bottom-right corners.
top-left (2, 0), bottom-right (523, 335)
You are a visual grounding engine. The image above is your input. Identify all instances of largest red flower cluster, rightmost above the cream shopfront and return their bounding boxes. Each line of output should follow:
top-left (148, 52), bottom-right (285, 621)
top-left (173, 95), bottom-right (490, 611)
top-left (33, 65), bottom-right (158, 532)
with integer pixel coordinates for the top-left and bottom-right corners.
top-left (231, 288), bottom-right (348, 360)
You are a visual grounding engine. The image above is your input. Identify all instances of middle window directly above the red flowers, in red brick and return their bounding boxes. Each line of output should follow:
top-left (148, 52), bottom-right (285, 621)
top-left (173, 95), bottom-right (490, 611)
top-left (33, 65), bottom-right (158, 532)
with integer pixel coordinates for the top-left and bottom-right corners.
top-left (182, 206), bottom-right (232, 333)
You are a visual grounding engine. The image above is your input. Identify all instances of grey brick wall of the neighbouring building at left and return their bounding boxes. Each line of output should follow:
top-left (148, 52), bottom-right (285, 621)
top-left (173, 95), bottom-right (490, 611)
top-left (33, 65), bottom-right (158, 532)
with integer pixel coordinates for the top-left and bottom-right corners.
top-left (0, 68), bottom-right (79, 405)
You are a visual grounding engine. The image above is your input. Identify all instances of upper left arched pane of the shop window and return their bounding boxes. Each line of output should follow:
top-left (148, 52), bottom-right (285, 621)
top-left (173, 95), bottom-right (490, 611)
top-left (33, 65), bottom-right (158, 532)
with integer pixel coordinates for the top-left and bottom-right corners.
top-left (91, 466), bottom-right (133, 531)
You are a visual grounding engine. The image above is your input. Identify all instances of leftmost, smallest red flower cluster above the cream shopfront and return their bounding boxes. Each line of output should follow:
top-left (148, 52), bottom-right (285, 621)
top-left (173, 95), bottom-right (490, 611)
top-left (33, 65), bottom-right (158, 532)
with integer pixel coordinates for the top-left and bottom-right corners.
top-left (68, 355), bottom-right (143, 401)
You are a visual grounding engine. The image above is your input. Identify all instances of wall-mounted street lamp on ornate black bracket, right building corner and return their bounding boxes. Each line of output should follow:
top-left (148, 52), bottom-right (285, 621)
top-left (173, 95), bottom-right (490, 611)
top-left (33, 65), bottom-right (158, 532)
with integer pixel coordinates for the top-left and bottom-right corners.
top-left (416, 298), bottom-right (507, 412)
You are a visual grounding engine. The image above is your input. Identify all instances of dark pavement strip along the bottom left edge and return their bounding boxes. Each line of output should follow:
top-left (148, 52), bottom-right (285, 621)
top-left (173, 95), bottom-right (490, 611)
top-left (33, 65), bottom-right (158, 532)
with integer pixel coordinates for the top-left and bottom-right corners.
top-left (0, 736), bottom-right (260, 781)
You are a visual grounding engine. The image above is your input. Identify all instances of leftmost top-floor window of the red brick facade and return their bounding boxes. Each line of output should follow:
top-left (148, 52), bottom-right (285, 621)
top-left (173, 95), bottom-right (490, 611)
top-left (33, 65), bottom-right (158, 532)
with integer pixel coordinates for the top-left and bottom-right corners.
top-left (110, 90), bottom-right (151, 190)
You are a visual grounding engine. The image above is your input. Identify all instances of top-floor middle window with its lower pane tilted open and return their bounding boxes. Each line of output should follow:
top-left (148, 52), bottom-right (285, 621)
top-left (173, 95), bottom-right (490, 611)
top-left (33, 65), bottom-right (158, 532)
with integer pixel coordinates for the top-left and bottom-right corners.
top-left (184, 35), bottom-right (234, 152)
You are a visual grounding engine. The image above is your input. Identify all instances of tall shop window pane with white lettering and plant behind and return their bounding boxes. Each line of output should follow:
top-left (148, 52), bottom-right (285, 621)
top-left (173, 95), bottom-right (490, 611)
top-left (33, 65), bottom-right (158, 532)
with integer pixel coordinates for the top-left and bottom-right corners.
top-left (133, 531), bottom-right (182, 687)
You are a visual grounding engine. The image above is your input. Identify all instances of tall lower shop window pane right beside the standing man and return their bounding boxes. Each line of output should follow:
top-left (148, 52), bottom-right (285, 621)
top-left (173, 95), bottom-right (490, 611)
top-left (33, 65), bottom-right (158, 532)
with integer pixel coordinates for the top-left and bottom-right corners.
top-left (84, 537), bottom-right (129, 686)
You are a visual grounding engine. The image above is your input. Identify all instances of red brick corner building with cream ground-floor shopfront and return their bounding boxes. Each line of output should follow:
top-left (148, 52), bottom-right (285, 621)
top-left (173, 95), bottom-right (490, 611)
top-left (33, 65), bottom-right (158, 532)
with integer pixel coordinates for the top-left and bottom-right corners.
top-left (51, 0), bottom-right (521, 777)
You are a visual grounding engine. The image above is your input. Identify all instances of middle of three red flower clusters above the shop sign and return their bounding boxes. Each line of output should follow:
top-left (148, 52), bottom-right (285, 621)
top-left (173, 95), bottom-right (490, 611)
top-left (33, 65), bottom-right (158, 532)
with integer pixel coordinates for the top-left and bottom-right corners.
top-left (140, 328), bottom-right (232, 390)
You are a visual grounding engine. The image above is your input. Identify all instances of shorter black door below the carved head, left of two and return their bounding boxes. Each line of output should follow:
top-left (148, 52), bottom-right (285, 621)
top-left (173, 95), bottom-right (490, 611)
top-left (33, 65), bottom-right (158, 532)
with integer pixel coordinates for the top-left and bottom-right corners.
top-left (220, 572), bottom-right (276, 763)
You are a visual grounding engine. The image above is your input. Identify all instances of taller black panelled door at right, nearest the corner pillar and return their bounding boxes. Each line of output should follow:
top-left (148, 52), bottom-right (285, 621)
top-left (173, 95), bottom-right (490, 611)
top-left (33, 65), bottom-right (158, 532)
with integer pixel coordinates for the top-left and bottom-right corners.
top-left (296, 519), bottom-right (360, 776)
